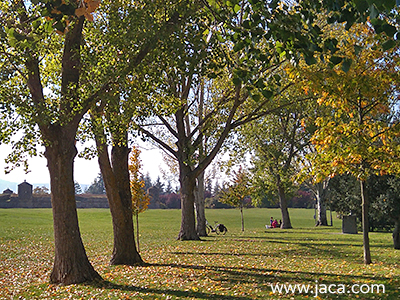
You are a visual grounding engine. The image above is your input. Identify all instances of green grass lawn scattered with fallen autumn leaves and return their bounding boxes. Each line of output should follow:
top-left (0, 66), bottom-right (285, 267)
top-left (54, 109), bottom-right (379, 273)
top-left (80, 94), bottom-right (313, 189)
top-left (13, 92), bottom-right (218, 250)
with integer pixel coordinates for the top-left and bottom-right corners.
top-left (0, 209), bottom-right (400, 300)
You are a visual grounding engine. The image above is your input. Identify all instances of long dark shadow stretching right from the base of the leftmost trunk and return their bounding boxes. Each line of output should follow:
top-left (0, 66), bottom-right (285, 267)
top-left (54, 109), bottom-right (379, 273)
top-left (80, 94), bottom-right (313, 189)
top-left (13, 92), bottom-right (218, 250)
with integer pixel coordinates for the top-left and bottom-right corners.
top-left (87, 280), bottom-right (253, 300)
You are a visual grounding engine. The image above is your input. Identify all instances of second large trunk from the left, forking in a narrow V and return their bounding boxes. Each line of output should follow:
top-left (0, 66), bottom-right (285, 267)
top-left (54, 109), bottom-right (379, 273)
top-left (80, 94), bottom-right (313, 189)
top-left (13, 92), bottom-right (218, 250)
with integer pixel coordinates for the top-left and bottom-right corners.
top-left (96, 131), bottom-right (143, 265)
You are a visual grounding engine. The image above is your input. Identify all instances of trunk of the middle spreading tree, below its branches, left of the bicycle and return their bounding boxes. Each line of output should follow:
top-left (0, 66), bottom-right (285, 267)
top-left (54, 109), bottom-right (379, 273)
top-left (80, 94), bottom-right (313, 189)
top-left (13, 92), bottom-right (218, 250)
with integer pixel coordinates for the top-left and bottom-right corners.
top-left (178, 164), bottom-right (200, 241)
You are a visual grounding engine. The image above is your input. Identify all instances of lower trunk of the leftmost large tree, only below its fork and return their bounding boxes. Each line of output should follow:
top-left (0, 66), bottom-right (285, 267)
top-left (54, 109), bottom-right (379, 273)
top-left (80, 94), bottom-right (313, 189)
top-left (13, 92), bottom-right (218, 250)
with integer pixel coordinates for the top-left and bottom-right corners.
top-left (42, 125), bottom-right (101, 284)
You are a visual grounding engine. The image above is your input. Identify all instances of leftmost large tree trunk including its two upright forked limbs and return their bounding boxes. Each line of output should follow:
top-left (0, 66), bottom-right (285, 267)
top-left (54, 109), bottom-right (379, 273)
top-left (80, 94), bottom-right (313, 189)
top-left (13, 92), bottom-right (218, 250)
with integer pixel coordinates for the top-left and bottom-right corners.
top-left (21, 13), bottom-right (101, 284)
